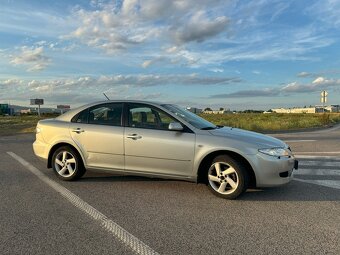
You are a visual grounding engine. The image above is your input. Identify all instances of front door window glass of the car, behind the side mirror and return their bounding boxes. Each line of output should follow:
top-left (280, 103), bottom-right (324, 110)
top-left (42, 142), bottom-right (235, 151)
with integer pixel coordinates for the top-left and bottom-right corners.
top-left (128, 104), bottom-right (178, 130)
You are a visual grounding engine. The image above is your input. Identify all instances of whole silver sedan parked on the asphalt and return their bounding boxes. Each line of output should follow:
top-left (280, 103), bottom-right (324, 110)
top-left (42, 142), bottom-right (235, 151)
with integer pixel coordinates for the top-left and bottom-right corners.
top-left (33, 101), bottom-right (298, 199)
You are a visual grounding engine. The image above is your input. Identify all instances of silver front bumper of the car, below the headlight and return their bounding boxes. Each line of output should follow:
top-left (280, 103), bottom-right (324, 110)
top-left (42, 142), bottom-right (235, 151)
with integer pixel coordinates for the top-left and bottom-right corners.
top-left (253, 153), bottom-right (298, 187)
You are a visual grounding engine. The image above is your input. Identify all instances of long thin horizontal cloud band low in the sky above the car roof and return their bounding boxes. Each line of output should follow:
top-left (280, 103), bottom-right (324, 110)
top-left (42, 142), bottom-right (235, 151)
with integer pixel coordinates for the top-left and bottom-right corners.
top-left (0, 74), bottom-right (241, 93)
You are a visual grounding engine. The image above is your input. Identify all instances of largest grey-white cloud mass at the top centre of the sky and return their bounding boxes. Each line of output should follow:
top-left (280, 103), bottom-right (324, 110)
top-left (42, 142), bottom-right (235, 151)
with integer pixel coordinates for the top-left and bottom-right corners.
top-left (64, 0), bottom-right (228, 54)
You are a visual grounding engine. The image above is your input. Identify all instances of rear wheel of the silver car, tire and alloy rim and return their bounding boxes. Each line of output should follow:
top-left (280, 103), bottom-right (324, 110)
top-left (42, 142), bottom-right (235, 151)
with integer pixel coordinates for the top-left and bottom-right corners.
top-left (52, 146), bottom-right (86, 181)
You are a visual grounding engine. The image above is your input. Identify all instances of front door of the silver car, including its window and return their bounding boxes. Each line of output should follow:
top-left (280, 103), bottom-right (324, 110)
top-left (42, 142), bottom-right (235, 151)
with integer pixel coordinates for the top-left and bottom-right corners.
top-left (124, 103), bottom-right (195, 176)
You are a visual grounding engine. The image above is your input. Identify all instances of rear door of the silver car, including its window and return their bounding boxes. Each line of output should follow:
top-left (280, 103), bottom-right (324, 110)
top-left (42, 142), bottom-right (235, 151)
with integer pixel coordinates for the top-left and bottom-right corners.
top-left (70, 103), bottom-right (124, 170)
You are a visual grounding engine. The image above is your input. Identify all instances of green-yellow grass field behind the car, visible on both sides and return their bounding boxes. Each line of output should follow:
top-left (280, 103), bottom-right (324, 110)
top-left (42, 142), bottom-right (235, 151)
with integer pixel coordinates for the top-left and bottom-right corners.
top-left (0, 113), bottom-right (340, 136)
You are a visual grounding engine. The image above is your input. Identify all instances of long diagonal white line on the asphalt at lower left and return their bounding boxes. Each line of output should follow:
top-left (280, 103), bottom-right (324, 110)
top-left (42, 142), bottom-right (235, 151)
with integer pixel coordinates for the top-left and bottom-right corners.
top-left (7, 151), bottom-right (158, 255)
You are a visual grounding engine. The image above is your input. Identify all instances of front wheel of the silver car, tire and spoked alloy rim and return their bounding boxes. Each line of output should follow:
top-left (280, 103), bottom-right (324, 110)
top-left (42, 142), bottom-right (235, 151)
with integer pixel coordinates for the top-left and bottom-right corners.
top-left (207, 155), bottom-right (249, 199)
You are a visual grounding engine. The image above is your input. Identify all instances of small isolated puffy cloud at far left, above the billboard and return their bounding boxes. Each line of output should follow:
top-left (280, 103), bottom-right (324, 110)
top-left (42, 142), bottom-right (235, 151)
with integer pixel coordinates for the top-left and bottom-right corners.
top-left (10, 46), bottom-right (51, 72)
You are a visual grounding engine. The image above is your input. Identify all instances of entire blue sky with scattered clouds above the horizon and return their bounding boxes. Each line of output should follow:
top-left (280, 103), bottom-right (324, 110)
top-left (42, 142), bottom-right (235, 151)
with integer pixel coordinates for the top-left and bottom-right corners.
top-left (0, 0), bottom-right (340, 110)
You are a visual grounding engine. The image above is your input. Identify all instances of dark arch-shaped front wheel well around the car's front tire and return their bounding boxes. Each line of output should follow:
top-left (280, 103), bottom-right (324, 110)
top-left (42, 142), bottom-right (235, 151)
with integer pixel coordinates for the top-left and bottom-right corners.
top-left (197, 150), bottom-right (256, 188)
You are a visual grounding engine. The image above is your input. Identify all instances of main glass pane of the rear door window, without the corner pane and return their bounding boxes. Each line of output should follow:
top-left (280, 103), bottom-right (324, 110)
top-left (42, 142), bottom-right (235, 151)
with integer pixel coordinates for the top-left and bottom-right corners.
top-left (88, 104), bottom-right (123, 126)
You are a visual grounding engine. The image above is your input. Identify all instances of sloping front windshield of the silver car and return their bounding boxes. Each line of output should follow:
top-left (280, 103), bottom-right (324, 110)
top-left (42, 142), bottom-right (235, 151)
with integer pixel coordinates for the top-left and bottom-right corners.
top-left (162, 104), bottom-right (217, 130)
